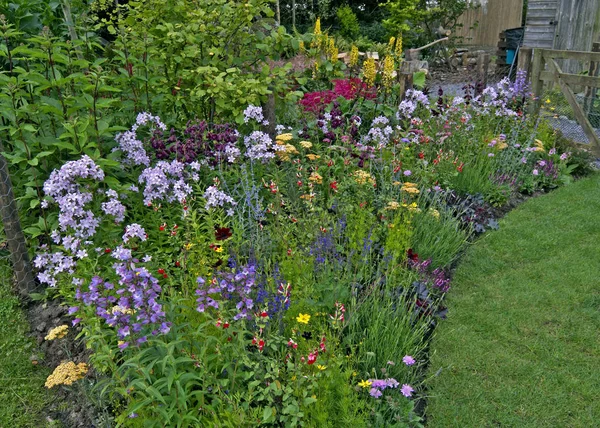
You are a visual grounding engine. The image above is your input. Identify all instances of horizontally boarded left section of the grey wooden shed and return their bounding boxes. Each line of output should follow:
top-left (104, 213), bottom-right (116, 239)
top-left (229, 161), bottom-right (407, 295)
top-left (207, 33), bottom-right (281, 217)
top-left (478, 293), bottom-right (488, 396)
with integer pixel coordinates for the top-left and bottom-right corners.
top-left (523, 0), bottom-right (560, 49)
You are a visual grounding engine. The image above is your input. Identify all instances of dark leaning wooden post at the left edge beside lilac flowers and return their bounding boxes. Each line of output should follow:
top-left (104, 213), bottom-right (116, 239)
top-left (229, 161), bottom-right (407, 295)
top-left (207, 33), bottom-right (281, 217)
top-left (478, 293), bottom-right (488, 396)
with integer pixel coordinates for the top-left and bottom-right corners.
top-left (0, 141), bottom-right (35, 300)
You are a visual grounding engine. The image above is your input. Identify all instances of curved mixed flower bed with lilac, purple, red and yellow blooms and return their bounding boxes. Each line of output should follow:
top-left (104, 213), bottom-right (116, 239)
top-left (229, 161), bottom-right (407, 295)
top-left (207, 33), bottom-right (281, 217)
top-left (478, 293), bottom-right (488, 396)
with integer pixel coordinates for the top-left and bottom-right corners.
top-left (34, 76), bottom-right (574, 426)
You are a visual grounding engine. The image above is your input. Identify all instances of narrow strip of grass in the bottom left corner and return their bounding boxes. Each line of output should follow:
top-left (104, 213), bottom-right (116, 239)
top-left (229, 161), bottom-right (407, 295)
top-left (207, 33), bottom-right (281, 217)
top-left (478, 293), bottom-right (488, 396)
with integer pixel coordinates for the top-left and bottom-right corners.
top-left (0, 257), bottom-right (51, 428)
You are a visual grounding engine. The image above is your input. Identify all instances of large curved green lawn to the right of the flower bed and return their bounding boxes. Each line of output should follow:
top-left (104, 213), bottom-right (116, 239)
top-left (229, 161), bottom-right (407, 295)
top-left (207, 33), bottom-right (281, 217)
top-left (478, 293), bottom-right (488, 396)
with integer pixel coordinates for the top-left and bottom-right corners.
top-left (427, 174), bottom-right (600, 428)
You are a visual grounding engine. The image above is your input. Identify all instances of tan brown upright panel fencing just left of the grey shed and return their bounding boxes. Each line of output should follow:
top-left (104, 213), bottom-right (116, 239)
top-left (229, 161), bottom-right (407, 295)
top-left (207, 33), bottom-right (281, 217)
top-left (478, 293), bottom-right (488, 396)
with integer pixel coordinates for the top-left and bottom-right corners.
top-left (456, 0), bottom-right (523, 46)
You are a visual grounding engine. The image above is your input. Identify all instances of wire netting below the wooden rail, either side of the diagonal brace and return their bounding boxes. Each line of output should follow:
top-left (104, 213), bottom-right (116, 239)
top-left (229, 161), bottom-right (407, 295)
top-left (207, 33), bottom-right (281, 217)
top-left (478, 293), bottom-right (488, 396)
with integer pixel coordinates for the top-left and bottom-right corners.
top-left (540, 85), bottom-right (600, 144)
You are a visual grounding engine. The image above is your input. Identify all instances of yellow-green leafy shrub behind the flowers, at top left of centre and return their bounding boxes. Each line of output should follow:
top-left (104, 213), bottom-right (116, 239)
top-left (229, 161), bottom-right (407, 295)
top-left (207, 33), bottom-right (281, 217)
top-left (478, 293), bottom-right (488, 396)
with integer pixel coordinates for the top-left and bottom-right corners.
top-left (108, 0), bottom-right (294, 121)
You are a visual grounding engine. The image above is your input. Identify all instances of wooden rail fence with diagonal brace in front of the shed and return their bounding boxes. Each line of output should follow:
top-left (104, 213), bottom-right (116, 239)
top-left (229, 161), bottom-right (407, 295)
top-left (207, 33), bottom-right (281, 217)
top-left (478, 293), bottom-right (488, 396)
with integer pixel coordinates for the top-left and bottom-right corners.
top-left (519, 44), bottom-right (600, 157)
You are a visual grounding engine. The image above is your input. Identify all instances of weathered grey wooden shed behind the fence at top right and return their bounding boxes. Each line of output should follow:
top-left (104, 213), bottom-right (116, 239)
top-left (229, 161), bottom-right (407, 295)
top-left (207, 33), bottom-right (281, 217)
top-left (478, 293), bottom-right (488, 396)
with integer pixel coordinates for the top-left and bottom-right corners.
top-left (523, 0), bottom-right (600, 73)
